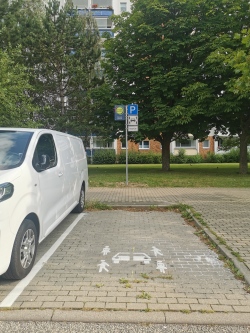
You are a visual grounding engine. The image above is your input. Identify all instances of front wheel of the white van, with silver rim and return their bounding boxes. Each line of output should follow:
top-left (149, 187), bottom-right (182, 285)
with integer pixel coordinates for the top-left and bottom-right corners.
top-left (2, 219), bottom-right (38, 280)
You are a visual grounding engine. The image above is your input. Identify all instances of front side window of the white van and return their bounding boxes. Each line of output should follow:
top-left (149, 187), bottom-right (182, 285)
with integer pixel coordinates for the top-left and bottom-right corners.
top-left (32, 134), bottom-right (57, 172)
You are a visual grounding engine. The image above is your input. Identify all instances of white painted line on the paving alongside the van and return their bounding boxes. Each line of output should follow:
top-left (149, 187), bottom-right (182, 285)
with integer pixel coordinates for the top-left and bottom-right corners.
top-left (0, 213), bottom-right (86, 308)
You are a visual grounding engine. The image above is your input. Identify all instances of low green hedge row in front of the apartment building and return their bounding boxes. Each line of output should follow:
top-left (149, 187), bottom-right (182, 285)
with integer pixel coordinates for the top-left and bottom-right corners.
top-left (89, 148), bottom-right (250, 164)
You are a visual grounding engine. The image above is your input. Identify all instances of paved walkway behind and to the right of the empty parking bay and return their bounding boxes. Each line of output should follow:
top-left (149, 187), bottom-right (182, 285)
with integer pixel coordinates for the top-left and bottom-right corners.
top-left (87, 186), bottom-right (250, 284)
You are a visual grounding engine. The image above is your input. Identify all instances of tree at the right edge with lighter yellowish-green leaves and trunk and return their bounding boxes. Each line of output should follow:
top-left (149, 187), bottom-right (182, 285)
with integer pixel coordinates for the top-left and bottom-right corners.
top-left (188, 8), bottom-right (250, 174)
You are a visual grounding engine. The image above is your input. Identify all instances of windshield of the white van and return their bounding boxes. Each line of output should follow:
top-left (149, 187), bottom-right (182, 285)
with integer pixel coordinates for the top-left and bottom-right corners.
top-left (0, 130), bottom-right (33, 170)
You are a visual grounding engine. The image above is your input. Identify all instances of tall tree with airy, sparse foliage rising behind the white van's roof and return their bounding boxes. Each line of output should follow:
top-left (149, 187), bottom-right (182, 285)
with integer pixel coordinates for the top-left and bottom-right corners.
top-left (26, 0), bottom-right (100, 134)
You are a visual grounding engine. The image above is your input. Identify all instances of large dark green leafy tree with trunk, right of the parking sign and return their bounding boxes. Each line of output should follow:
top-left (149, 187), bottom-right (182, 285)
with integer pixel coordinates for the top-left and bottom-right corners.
top-left (104, 0), bottom-right (248, 171)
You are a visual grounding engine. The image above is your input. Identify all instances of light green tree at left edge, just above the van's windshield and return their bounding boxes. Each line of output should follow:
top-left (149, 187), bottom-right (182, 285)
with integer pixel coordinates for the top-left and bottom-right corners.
top-left (0, 49), bottom-right (36, 127)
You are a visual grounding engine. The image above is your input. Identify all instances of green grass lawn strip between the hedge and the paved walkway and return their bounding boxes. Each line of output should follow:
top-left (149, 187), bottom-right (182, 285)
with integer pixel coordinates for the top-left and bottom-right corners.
top-left (89, 163), bottom-right (250, 188)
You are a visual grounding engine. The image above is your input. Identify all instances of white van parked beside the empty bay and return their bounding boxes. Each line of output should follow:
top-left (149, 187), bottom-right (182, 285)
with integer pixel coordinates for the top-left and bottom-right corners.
top-left (0, 128), bottom-right (88, 279)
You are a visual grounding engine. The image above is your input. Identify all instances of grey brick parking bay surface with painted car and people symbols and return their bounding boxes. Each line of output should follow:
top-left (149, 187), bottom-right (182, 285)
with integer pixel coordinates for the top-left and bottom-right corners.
top-left (0, 210), bottom-right (250, 313)
